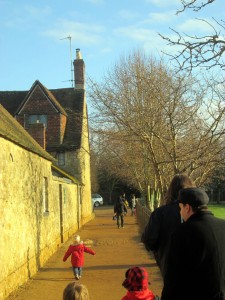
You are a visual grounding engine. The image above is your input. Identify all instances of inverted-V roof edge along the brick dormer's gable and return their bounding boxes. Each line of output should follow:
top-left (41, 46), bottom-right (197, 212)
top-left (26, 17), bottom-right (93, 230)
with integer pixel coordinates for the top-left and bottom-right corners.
top-left (15, 80), bottom-right (67, 116)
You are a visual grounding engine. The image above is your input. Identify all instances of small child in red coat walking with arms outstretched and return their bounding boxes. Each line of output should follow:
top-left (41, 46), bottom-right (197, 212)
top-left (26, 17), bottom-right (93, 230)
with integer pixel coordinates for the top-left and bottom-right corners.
top-left (63, 235), bottom-right (95, 280)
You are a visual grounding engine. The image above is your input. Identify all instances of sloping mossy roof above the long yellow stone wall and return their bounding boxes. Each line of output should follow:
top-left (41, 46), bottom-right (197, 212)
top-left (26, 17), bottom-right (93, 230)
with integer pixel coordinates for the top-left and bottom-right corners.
top-left (0, 104), bottom-right (55, 161)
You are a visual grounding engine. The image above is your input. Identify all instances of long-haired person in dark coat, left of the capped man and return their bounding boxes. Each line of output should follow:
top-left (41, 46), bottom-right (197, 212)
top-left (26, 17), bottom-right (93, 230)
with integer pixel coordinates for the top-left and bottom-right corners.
top-left (141, 174), bottom-right (195, 277)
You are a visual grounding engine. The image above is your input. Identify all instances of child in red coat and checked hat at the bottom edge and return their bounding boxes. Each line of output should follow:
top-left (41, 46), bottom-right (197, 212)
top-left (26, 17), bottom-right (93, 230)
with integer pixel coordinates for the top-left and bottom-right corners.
top-left (121, 267), bottom-right (159, 300)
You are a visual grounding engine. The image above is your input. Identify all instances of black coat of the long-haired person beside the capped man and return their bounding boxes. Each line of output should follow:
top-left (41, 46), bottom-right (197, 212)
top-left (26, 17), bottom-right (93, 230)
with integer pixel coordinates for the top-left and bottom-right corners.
top-left (141, 201), bottom-right (181, 277)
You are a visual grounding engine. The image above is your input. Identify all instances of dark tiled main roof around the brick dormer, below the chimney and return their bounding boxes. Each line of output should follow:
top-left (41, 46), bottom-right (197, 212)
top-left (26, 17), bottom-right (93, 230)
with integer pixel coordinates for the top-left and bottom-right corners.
top-left (0, 80), bottom-right (85, 151)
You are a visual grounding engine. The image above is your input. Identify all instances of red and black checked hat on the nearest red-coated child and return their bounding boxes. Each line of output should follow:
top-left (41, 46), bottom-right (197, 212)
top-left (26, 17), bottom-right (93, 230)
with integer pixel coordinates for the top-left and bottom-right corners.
top-left (122, 267), bottom-right (149, 291)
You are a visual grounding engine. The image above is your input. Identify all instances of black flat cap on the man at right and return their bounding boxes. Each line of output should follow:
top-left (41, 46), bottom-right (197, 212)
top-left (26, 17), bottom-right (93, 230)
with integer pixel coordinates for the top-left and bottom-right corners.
top-left (178, 188), bottom-right (209, 208)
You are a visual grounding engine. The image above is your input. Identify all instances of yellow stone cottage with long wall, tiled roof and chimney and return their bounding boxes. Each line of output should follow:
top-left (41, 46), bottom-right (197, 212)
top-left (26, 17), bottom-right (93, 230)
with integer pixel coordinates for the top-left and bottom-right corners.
top-left (0, 49), bottom-right (93, 299)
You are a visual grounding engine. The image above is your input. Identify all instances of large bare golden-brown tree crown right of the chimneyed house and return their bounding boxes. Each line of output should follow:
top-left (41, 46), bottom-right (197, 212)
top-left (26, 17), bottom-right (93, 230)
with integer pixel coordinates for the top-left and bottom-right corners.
top-left (89, 52), bottom-right (224, 205)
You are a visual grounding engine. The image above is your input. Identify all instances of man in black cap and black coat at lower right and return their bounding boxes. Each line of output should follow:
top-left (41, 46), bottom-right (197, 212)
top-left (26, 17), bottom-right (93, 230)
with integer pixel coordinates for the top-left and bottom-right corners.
top-left (161, 188), bottom-right (225, 300)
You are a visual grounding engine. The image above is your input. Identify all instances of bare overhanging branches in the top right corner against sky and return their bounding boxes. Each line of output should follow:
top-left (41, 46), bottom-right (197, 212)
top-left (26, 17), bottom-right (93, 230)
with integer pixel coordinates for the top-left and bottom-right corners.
top-left (159, 0), bottom-right (225, 72)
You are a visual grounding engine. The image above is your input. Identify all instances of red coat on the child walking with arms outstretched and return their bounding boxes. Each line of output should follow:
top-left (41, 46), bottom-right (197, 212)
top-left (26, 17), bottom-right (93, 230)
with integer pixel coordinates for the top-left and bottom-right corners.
top-left (63, 243), bottom-right (95, 267)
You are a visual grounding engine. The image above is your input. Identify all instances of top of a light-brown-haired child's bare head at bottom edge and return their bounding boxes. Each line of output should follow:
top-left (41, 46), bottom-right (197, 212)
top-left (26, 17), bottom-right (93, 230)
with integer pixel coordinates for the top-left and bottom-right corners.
top-left (63, 282), bottom-right (89, 300)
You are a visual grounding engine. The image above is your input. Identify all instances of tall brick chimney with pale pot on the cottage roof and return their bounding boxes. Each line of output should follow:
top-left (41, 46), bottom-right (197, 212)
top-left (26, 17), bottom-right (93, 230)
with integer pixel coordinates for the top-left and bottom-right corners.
top-left (73, 49), bottom-right (85, 89)
